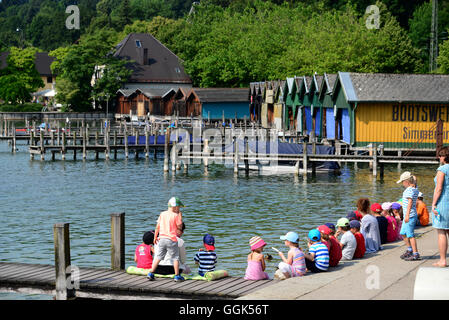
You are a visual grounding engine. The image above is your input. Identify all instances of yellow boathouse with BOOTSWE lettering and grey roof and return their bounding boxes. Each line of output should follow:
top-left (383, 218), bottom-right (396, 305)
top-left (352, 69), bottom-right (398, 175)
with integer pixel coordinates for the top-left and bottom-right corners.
top-left (332, 72), bottom-right (449, 150)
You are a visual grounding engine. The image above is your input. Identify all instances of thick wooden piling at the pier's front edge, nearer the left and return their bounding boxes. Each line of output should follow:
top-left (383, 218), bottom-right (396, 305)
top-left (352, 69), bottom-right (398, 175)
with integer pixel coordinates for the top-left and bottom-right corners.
top-left (53, 223), bottom-right (75, 300)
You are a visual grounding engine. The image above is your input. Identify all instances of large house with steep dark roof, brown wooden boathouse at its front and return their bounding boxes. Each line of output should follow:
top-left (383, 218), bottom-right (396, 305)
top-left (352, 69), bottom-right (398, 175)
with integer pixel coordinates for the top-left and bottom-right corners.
top-left (114, 33), bottom-right (192, 116)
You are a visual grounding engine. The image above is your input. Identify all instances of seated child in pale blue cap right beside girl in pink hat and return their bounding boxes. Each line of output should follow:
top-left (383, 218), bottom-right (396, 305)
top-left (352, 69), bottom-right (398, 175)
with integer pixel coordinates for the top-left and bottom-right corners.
top-left (278, 232), bottom-right (306, 278)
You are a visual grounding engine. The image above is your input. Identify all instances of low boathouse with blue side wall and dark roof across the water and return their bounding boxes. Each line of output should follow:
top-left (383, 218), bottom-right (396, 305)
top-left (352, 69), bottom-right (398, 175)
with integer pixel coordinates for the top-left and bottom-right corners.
top-left (186, 88), bottom-right (250, 120)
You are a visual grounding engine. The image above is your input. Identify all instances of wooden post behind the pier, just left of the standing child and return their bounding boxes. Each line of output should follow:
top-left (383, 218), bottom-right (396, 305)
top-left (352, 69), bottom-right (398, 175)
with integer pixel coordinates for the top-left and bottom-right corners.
top-left (111, 212), bottom-right (125, 271)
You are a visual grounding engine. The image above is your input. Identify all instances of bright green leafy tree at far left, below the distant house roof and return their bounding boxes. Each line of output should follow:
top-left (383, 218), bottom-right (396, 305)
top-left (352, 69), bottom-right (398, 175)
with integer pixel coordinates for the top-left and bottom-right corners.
top-left (0, 47), bottom-right (44, 103)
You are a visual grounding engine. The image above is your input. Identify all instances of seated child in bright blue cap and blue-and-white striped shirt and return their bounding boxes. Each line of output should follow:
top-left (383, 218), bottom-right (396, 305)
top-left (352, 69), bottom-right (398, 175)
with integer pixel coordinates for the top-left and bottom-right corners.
top-left (304, 229), bottom-right (329, 273)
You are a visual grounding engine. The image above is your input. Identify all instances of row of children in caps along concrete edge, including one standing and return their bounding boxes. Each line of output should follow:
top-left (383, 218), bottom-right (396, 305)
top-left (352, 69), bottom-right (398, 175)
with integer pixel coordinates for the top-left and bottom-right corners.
top-left (245, 172), bottom-right (429, 280)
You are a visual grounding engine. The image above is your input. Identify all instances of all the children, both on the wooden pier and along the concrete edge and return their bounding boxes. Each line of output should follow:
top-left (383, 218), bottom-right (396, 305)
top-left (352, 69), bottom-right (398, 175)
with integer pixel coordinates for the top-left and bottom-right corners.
top-left (134, 172), bottom-right (429, 281)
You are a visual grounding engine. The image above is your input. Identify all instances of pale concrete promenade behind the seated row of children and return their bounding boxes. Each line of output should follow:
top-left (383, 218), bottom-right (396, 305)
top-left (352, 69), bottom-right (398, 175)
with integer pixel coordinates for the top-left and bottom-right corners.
top-left (239, 226), bottom-right (442, 300)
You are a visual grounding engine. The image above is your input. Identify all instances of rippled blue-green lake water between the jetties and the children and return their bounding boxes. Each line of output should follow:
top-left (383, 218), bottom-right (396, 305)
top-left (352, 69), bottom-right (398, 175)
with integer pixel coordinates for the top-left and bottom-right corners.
top-left (0, 142), bottom-right (437, 299)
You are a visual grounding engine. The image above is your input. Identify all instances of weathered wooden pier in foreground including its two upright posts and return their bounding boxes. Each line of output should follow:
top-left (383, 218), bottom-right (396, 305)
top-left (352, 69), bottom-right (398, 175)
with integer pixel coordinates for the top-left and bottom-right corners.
top-left (0, 213), bottom-right (277, 300)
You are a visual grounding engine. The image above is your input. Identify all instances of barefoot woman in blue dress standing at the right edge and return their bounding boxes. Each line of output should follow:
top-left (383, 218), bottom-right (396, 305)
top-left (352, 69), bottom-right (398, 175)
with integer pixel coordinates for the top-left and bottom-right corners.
top-left (432, 147), bottom-right (449, 268)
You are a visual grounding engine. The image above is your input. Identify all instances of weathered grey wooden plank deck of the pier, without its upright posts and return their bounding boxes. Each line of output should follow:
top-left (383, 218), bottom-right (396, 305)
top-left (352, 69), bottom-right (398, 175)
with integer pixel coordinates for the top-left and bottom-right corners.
top-left (0, 262), bottom-right (277, 300)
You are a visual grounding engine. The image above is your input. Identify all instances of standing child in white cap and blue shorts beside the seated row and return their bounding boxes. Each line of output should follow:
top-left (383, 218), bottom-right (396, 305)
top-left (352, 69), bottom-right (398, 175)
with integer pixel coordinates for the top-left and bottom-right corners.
top-left (397, 171), bottom-right (421, 261)
